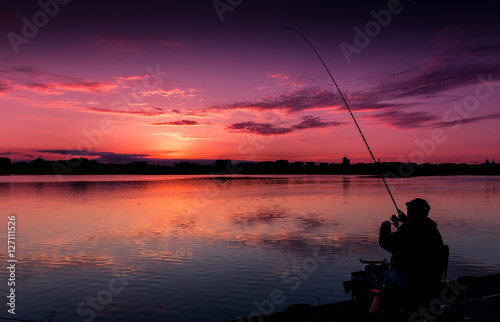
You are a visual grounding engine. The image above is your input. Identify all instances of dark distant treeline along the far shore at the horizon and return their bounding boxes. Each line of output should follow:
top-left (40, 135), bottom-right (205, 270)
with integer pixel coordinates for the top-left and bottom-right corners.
top-left (0, 158), bottom-right (500, 177)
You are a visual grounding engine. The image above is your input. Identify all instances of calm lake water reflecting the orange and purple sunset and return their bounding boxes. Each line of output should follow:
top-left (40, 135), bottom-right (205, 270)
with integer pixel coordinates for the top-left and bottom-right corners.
top-left (0, 175), bottom-right (500, 322)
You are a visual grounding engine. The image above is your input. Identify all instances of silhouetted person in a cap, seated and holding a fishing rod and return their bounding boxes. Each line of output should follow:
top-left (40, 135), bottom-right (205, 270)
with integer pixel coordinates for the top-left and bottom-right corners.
top-left (370, 198), bottom-right (443, 312)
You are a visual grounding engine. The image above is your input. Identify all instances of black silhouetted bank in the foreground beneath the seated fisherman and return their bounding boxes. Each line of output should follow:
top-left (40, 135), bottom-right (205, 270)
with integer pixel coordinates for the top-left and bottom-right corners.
top-left (226, 274), bottom-right (500, 322)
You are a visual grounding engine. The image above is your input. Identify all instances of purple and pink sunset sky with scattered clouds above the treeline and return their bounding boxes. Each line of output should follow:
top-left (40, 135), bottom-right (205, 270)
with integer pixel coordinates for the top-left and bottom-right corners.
top-left (0, 0), bottom-right (500, 164)
